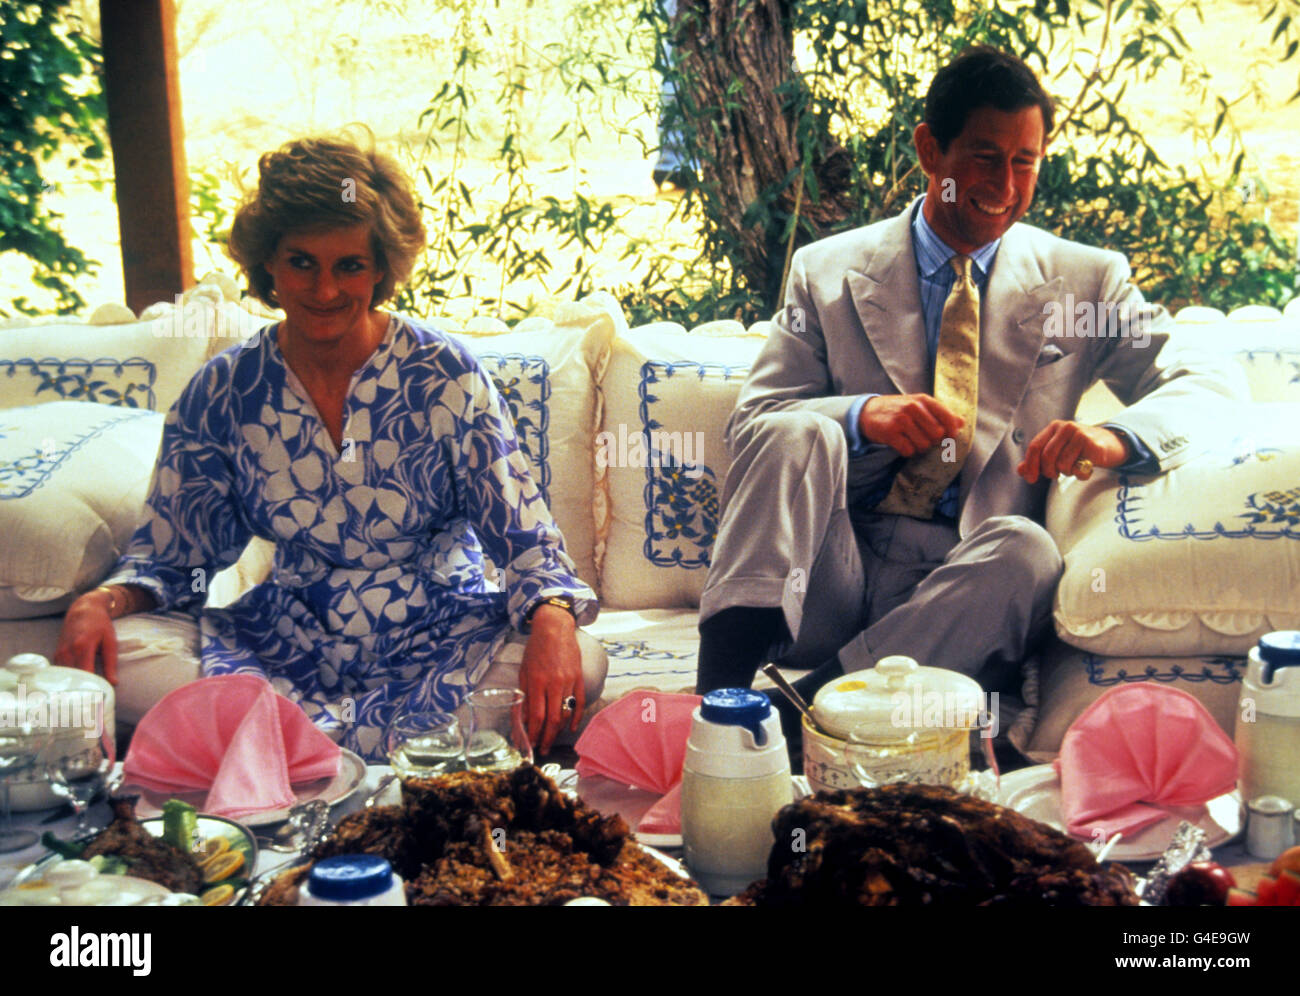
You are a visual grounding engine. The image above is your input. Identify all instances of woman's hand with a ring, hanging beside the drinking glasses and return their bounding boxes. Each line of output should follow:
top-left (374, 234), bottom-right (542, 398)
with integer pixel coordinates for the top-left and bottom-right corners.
top-left (519, 605), bottom-right (586, 754)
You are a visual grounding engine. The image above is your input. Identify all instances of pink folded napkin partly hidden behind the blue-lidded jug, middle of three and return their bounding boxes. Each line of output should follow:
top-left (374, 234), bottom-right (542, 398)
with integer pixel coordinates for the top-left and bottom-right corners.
top-left (575, 690), bottom-right (702, 833)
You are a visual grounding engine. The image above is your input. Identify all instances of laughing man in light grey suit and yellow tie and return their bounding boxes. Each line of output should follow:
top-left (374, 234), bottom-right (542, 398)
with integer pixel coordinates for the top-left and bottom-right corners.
top-left (697, 47), bottom-right (1227, 719)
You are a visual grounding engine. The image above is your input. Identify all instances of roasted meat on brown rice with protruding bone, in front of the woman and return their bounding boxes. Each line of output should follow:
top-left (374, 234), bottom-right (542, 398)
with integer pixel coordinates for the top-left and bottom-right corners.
top-left (261, 765), bottom-right (707, 906)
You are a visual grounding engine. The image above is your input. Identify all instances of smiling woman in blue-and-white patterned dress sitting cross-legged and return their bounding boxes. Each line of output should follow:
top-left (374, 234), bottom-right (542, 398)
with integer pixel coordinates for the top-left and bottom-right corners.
top-left (57, 132), bottom-right (605, 759)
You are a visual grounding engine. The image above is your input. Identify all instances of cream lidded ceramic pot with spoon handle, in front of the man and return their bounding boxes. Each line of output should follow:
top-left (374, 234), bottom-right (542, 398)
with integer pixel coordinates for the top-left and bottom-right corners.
top-left (803, 657), bottom-right (984, 792)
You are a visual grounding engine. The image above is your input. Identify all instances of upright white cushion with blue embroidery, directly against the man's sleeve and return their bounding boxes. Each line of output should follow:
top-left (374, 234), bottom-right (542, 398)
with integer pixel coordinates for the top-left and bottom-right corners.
top-left (595, 322), bottom-right (763, 609)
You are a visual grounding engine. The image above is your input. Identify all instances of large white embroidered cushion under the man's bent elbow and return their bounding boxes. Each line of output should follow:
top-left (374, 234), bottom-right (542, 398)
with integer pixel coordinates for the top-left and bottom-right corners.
top-left (1047, 404), bottom-right (1300, 657)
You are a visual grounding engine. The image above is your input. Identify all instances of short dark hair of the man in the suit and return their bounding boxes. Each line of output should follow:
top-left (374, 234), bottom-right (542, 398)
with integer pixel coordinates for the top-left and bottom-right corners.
top-left (926, 46), bottom-right (1056, 152)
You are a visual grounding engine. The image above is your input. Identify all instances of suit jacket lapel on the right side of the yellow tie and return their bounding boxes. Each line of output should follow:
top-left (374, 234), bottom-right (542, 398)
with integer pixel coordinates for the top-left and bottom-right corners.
top-left (962, 225), bottom-right (1061, 507)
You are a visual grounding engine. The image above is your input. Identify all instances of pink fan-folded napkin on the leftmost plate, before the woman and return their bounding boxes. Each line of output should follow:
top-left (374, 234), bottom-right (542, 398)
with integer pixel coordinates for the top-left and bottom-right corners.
top-left (122, 675), bottom-right (341, 818)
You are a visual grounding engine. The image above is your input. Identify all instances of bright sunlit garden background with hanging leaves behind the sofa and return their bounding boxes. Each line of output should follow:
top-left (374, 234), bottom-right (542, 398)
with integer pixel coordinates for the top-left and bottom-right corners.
top-left (0, 0), bottom-right (1300, 326)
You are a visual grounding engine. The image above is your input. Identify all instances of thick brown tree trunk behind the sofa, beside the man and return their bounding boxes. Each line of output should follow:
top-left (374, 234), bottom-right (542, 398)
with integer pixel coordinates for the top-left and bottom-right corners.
top-left (671, 0), bottom-right (852, 308)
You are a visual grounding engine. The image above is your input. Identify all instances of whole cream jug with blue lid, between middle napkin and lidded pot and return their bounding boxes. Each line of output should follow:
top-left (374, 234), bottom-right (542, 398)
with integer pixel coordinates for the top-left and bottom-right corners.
top-left (681, 688), bottom-right (794, 896)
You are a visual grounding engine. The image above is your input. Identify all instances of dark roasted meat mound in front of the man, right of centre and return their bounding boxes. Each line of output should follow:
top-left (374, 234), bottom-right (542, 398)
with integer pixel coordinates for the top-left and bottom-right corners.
top-left (731, 784), bottom-right (1138, 906)
